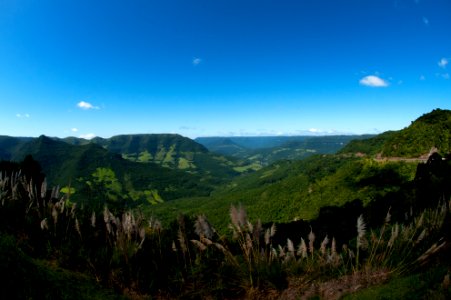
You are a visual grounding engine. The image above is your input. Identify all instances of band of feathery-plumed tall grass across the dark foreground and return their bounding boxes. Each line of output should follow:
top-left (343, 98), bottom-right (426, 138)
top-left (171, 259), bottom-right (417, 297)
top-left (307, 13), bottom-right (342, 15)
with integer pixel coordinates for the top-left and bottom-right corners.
top-left (0, 169), bottom-right (451, 298)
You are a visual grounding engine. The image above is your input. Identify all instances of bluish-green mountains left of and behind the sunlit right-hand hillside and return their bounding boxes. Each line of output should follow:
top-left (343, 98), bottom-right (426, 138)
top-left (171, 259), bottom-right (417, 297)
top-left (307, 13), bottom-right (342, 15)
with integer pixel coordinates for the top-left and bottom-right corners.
top-left (0, 134), bottom-right (360, 201)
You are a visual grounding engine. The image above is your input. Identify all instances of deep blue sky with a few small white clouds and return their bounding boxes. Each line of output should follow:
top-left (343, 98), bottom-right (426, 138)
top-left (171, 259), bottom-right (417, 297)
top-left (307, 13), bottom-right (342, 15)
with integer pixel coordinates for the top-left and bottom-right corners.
top-left (0, 0), bottom-right (451, 137)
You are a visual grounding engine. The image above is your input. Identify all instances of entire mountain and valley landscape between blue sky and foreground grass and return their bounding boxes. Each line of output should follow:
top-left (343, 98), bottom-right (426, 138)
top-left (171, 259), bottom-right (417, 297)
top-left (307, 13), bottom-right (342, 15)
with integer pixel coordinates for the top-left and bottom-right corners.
top-left (0, 109), bottom-right (451, 213)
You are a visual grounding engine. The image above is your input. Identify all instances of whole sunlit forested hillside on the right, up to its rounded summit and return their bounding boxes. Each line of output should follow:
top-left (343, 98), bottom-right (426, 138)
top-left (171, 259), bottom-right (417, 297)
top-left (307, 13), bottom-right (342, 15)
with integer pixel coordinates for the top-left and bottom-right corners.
top-left (151, 110), bottom-right (451, 228)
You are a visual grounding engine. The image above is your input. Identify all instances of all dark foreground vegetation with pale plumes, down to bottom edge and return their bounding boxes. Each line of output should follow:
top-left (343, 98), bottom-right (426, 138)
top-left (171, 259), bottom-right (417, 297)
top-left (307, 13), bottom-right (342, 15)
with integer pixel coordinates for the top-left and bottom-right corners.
top-left (0, 159), bottom-right (451, 299)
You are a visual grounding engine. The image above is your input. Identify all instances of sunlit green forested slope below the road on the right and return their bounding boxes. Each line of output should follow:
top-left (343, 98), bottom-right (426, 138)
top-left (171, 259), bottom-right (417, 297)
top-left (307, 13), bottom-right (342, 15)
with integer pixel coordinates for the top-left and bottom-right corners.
top-left (148, 155), bottom-right (417, 230)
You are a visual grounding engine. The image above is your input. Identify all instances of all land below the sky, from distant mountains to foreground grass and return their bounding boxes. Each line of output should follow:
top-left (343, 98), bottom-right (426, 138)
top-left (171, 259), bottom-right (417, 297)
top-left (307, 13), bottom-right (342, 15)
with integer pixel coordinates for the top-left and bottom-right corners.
top-left (0, 110), bottom-right (451, 299)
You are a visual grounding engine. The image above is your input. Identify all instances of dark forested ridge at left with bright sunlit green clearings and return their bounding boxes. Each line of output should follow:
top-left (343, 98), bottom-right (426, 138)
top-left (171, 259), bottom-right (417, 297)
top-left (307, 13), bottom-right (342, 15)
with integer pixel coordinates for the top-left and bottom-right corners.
top-left (0, 136), bottom-right (222, 205)
